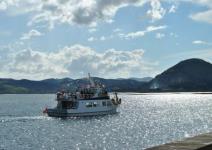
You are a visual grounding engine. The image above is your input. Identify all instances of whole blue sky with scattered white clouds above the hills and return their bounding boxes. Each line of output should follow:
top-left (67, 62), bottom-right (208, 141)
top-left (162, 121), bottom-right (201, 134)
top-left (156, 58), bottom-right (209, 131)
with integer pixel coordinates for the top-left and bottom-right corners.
top-left (0, 0), bottom-right (212, 80)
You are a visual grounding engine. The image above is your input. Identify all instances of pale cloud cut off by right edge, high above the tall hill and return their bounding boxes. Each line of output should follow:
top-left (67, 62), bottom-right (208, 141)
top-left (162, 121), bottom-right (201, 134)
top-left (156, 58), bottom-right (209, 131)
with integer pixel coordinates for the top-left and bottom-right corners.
top-left (190, 10), bottom-right (212, 24)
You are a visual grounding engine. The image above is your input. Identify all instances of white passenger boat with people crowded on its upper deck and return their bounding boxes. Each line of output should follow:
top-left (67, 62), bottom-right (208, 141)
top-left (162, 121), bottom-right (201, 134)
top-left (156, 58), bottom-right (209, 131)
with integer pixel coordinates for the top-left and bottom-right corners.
top-left (43, 74), bottom-right (121, 117)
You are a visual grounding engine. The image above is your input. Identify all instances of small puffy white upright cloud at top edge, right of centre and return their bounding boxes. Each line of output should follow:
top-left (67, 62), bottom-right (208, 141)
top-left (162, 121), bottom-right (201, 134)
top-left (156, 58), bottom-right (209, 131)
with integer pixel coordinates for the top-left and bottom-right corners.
top-left (146, 0), bottom-right (166, 22)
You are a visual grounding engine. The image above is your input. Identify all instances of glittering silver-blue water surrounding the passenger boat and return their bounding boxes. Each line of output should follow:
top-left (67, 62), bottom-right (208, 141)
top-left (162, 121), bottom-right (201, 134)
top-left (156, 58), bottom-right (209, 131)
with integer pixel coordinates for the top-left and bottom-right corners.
top-left (0, 93), bottom-right (212, 150)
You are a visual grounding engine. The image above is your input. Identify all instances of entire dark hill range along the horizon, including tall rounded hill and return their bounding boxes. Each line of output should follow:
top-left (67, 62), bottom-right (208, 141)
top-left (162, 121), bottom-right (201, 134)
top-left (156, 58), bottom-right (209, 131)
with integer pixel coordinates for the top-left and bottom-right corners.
top-left (0, 59), bottom-right (212, 94)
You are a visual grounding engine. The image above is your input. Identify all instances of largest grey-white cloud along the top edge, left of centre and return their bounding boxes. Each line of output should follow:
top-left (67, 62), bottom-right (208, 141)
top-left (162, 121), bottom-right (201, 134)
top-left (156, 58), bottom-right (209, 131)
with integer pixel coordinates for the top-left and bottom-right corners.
top-left (0, 0), bottom-right (149, 29)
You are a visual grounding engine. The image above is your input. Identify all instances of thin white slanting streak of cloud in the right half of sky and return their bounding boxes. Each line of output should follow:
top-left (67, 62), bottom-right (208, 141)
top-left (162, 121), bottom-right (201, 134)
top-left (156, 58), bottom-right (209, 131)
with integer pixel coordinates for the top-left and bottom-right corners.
top-left (119, 25), bottom-right (167, 39)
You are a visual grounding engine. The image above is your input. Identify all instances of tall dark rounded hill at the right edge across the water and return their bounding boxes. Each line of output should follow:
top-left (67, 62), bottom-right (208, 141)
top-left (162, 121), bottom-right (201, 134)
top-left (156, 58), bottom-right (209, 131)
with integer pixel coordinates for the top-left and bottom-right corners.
top-left (149, 59), bottom-right (212, 91)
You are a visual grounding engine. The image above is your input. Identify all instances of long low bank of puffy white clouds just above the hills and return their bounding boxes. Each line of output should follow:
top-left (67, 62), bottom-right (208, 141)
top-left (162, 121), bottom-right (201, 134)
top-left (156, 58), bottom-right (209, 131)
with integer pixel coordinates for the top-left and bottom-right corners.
top-left (0, 45), bottom-right (155, 79)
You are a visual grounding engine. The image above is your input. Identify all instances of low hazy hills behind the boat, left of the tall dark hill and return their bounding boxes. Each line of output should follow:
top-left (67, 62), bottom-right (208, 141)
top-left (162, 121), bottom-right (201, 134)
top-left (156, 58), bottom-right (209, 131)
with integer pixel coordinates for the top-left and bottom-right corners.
top-left (0, 77), bottom-right (144, 94)
